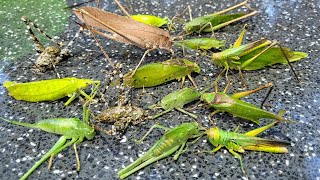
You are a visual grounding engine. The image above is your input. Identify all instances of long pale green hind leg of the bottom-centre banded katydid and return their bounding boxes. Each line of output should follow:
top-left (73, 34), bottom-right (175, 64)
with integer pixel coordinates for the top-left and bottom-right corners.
top-left (118, 146), bottom-right (179, 179)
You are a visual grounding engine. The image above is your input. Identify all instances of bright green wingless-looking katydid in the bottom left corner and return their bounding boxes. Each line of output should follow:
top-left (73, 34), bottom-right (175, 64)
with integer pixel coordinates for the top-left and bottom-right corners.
top-left (1, 106), bottom-right (95, 180)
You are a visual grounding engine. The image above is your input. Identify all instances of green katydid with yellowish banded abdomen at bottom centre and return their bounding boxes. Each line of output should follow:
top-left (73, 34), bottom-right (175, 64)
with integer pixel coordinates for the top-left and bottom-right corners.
top-left (118, 122), bottom-right (203, 179)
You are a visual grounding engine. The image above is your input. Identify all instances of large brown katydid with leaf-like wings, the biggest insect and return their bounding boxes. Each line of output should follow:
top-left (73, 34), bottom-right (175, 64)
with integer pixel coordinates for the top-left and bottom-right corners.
top-left (73, 6), bottom-right (174, 74)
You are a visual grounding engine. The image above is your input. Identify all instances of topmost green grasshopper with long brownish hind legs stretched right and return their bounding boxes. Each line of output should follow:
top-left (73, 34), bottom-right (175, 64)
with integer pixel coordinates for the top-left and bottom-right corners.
top-left (184, 1), bottom-right (257, 34)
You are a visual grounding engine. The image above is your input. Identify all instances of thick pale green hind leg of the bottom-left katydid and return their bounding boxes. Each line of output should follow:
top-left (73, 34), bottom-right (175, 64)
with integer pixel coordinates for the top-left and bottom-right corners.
top-left (20, 136), bottom-right (67, 179)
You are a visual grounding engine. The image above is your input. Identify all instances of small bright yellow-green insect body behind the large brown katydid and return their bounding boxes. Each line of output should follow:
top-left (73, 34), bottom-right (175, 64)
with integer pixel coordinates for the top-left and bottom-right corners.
top-left (131, 14), bottom-right (169, 27)
